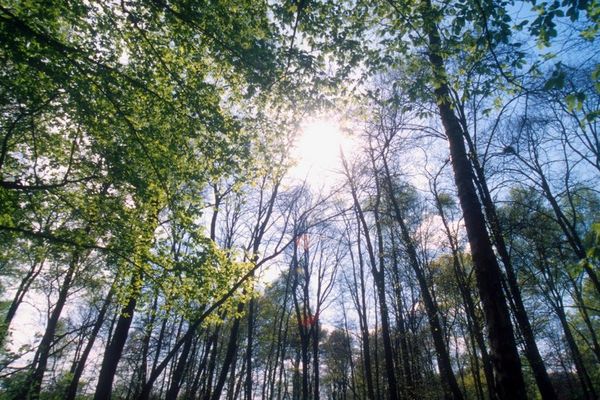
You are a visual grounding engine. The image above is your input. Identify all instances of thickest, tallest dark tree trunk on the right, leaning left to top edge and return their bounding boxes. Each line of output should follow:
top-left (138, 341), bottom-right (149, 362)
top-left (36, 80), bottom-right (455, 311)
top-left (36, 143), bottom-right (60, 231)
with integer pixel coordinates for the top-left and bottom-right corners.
top-left (422, 0), bottom-right (527, 400)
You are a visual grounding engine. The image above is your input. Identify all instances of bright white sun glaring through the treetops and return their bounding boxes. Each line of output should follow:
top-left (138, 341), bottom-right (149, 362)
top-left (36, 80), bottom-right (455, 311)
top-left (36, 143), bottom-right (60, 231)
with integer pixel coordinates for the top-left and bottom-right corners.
top-left (291, 118), bottom-right (355, 186)
